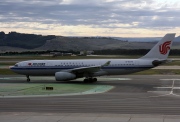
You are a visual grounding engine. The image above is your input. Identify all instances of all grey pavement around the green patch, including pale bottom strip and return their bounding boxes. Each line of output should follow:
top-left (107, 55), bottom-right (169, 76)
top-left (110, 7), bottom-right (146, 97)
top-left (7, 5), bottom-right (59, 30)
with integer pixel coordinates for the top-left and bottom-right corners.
top-left (0, 75), bottom-right (180, 122)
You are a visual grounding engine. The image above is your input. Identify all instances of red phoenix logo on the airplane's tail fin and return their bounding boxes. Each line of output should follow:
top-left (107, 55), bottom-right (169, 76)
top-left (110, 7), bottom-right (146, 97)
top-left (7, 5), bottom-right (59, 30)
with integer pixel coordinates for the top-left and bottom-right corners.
top-left (159, 41), bottom-right (171, 55)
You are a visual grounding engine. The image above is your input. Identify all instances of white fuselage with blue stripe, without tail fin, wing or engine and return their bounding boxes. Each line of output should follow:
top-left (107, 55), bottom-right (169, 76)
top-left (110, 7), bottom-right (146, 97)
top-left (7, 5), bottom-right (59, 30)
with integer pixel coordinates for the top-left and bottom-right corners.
top-left (10, 59), bottom-right (155, 77)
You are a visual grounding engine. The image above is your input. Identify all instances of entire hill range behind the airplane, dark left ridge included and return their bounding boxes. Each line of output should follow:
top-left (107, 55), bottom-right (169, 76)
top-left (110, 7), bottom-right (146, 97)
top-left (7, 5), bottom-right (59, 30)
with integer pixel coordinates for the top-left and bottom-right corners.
top-left (0, 32), bottom-right (180, 52)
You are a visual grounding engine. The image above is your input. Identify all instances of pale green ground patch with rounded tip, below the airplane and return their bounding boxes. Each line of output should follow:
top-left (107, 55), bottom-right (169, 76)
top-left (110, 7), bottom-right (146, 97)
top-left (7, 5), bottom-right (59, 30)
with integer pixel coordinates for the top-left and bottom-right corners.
top-left (0, 83), bottom-right (97, 96)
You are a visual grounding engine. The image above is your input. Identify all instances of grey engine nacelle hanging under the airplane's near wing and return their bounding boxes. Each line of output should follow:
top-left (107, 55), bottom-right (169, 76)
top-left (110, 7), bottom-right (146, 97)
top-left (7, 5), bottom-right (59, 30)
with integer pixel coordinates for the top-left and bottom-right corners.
top-left (55, 72), bottom-right (76, 81)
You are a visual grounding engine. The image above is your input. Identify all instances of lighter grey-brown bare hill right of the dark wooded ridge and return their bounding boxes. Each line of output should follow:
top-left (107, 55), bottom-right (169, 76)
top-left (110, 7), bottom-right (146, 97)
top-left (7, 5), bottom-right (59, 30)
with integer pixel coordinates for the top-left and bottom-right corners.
top-left (36, 37), bottom-right (159, 51)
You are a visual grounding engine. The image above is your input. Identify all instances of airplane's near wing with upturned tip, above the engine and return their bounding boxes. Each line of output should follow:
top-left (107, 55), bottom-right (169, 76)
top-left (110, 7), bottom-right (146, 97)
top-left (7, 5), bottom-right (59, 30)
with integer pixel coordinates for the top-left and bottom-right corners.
top-left (62, 61), bottom-right (111, 74)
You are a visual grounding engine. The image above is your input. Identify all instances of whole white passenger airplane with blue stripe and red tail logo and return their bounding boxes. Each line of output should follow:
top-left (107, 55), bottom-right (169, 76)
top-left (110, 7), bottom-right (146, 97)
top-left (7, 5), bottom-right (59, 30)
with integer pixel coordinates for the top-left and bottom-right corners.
top-left (10, 33), bottom-right (175, 83)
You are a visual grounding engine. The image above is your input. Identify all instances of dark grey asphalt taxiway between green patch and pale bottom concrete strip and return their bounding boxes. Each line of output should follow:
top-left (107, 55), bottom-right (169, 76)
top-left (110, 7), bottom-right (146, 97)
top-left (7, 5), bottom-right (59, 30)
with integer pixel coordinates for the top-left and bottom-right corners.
top-left (0, 75), bottom-right (180, 121)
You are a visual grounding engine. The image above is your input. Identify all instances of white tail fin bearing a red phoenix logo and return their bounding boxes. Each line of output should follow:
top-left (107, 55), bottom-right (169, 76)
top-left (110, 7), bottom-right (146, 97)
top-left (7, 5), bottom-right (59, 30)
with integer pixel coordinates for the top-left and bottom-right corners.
top-left (141, 33), bottom-right (176, 59)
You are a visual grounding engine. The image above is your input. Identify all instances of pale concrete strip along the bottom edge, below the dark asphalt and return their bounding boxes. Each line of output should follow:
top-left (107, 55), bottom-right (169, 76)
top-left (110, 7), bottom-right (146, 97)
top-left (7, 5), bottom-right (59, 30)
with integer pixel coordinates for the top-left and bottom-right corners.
top-left (0, 112), bottom-right (180, 122)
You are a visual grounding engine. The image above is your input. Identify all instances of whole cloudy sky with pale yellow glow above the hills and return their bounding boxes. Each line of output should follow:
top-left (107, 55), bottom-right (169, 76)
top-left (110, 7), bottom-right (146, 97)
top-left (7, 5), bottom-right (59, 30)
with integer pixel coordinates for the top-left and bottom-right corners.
top-left (0, 0), bottom-right (180, 37)
